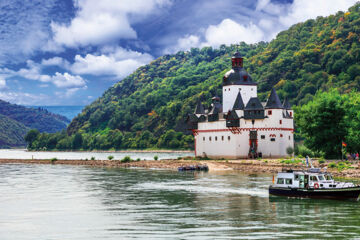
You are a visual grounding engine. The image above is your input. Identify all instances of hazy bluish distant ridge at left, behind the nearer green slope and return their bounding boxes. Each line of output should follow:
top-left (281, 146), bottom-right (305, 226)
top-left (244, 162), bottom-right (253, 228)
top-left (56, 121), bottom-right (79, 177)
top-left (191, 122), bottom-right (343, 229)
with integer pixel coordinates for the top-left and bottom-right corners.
top-left (0, 100), bottom-right (70, 133)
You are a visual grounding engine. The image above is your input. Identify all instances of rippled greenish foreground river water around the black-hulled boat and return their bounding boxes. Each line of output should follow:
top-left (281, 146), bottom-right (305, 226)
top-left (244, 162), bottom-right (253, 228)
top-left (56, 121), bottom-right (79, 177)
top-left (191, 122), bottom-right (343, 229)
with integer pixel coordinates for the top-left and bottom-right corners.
top-left (0, 164), bottom-right (360, 240)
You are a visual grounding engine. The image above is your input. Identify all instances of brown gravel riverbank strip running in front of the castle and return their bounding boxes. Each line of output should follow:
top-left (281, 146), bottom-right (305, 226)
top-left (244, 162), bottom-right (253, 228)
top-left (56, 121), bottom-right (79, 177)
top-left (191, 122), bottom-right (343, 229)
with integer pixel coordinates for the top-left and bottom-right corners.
top-left (0, 159), bottom-right (360, 178)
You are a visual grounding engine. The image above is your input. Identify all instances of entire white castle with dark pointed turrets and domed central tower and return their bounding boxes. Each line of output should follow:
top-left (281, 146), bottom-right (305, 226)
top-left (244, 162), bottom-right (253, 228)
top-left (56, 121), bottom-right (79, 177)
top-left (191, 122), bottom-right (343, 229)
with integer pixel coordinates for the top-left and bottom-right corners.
top-left (187, 52), bottom-right (294, 159)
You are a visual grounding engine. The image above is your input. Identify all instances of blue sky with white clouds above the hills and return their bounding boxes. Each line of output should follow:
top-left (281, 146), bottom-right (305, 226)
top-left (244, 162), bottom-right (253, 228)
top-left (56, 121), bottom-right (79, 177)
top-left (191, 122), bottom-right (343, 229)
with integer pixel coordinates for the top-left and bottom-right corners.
top-left (0, 0), bottom-right (357, 106)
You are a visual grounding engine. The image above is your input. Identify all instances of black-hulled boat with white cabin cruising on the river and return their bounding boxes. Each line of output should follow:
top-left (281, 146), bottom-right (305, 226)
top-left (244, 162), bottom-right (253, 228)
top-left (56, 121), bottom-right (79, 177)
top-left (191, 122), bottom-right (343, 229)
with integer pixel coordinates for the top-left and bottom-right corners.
top-left (269, 168), bottom-right (360, 201)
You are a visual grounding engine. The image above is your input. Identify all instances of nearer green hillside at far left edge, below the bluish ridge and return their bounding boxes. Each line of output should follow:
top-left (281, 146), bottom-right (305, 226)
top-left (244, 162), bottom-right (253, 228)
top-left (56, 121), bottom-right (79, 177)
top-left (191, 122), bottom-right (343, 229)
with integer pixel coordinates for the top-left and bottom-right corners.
top-left (0, 114), bottom-right (30, 148)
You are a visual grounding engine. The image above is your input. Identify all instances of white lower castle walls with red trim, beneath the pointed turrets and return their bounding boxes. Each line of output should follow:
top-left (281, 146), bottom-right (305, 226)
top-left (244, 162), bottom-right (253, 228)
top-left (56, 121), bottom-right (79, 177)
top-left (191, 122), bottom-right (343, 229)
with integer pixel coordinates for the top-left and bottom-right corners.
top-left (195, 109), bottom-right (294, 159)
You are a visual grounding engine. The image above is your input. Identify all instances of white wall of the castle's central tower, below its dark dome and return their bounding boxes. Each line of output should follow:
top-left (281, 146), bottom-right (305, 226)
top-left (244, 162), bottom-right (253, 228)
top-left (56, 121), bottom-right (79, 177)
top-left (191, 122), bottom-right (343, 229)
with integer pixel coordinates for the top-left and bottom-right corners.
top-left (223, 85), bottom-right (257, 112)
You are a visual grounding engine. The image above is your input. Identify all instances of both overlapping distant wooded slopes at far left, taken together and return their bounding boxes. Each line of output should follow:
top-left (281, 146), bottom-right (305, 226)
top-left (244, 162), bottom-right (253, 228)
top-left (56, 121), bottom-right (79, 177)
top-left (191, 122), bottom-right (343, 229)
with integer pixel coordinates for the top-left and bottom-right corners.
top-left (0, 100), bottom-right (70, 148)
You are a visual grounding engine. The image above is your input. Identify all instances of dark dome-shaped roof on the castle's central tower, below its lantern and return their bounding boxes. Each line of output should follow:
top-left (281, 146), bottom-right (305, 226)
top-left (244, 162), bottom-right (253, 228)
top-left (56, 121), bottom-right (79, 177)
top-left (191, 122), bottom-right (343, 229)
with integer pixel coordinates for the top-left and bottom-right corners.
top-left (223, 67), bottom-right (257, 86)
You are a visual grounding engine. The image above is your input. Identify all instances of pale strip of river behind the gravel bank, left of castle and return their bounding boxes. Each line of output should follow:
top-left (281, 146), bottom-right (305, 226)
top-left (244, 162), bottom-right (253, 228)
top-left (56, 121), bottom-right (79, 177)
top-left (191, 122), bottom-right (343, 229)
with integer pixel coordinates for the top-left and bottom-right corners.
top-left (0, 149), bottom-right (194, 160)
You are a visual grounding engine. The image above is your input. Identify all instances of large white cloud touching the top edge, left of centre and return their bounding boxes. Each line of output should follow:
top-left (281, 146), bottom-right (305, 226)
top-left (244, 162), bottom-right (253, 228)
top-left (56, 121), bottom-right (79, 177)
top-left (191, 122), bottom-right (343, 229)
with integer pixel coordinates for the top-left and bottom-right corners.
top-left (51, 0), bottom-right (169, 48)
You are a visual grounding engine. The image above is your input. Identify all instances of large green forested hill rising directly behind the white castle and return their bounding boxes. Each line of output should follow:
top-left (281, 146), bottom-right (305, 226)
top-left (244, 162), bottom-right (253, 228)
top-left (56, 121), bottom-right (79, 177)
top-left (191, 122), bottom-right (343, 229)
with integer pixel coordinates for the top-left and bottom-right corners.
top-left (27, 4), bottom-right (360, 149)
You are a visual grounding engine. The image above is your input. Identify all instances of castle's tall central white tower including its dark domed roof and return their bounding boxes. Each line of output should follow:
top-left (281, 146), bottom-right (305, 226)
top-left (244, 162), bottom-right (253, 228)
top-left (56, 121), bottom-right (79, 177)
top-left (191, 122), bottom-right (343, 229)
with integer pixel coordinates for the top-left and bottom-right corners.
top-left (223, 52), bottom-right (257, 112)
